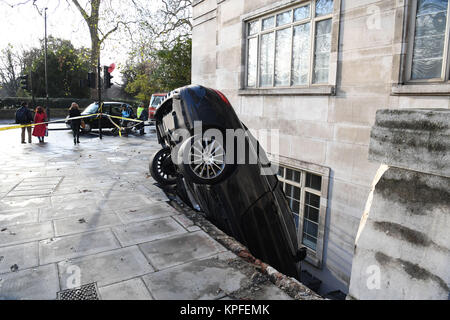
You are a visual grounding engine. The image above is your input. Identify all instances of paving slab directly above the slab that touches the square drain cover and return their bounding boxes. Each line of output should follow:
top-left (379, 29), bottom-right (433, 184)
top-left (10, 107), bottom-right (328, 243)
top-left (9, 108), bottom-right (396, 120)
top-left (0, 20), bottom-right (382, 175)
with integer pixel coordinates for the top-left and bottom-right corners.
top-left (39, 230), bottom-right (120, 264)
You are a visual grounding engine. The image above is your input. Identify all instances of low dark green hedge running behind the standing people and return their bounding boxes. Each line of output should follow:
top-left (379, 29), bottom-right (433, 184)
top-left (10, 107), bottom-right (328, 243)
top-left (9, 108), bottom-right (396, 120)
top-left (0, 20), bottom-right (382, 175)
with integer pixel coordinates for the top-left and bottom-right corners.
top-left (0, 97), bottom-right (139, 110)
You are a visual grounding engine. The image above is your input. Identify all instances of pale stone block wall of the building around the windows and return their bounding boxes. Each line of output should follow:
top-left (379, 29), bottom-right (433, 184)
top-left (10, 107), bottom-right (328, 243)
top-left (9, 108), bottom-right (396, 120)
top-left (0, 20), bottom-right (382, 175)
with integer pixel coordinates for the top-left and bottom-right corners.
top-left (192, 0), bottom-right (450, 293)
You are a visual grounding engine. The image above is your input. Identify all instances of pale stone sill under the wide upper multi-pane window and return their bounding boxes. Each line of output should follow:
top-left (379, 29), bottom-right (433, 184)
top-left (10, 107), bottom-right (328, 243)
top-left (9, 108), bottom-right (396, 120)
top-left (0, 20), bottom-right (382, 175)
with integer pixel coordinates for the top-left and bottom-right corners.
top-left (239, 85), bottom-right (336, 96)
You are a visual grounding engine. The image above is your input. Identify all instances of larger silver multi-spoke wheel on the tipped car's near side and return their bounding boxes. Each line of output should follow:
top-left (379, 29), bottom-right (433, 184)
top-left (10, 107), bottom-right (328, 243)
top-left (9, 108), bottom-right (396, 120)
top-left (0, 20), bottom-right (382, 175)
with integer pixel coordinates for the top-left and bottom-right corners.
top-left (177, 136), bottom-right (235, 185)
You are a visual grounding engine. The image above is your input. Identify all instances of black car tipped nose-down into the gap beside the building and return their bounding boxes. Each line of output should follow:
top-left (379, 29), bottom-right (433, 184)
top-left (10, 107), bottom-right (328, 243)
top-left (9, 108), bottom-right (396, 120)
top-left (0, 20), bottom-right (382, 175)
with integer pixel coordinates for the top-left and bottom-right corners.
top-left (150, 86), bottom-right (306, 279)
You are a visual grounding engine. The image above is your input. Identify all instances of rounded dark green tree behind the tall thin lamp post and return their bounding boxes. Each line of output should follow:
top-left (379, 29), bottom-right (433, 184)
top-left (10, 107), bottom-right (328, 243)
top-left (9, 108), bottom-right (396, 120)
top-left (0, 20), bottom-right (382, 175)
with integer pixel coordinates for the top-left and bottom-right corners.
top-left (23, 37), bottom-right (90, 98)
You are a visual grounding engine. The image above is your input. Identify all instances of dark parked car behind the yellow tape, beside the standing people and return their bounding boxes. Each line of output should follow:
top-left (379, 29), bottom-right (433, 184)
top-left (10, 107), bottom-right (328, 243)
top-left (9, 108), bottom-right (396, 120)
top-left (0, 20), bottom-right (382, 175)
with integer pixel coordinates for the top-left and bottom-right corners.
top-left (66, 102), bottom-right (132, 133)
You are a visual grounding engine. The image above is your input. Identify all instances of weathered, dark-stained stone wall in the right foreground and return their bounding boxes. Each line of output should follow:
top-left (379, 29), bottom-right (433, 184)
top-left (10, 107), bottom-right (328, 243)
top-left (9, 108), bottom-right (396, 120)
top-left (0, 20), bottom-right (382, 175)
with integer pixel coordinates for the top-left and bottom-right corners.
top-left (349, 110), bottom-right (450, 299)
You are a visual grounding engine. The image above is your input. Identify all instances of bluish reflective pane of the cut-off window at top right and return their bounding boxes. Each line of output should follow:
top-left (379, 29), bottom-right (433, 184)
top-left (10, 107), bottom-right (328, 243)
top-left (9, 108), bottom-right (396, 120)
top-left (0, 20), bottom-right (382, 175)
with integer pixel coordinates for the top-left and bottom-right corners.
top-left (411, 0), bottom-right (448, 80)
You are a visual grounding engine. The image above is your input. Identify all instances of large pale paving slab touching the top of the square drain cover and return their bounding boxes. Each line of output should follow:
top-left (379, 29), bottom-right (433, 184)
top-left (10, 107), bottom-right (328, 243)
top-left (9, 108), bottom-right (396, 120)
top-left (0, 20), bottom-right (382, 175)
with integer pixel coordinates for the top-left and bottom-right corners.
top-left (58, 246), bottom-right (154, 290)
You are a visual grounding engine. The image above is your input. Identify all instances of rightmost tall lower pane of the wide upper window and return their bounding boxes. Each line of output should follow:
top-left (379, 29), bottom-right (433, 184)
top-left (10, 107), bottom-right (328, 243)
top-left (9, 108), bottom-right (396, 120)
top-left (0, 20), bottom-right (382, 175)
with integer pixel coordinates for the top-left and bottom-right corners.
top-left (313, 19), bottom-right (331, 83)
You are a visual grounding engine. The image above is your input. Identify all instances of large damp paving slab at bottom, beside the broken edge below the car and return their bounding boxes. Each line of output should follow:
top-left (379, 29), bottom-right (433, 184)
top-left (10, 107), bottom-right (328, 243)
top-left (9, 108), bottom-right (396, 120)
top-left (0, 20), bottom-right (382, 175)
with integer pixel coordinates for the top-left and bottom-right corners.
top-left (143, 252), bottom-right (250, 300)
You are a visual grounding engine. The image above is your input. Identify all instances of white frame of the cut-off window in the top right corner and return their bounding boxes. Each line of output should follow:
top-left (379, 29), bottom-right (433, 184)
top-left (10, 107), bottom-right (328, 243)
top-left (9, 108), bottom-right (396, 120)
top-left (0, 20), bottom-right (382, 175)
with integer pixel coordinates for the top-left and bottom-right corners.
top-left (405, 0), bottom-right (450, 84)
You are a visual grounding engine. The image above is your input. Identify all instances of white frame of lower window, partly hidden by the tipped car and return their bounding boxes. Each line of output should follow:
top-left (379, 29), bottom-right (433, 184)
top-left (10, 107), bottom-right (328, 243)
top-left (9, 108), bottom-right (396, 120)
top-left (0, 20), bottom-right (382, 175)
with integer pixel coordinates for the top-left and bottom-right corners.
top-left (269, 155), bottom-right (330, 269)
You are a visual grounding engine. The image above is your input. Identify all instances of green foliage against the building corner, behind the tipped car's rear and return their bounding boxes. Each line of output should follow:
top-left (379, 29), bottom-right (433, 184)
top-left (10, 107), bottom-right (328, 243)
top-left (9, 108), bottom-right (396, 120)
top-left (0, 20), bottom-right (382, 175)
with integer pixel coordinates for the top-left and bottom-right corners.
top-left (122, 38), bottom-right (192, 101)
